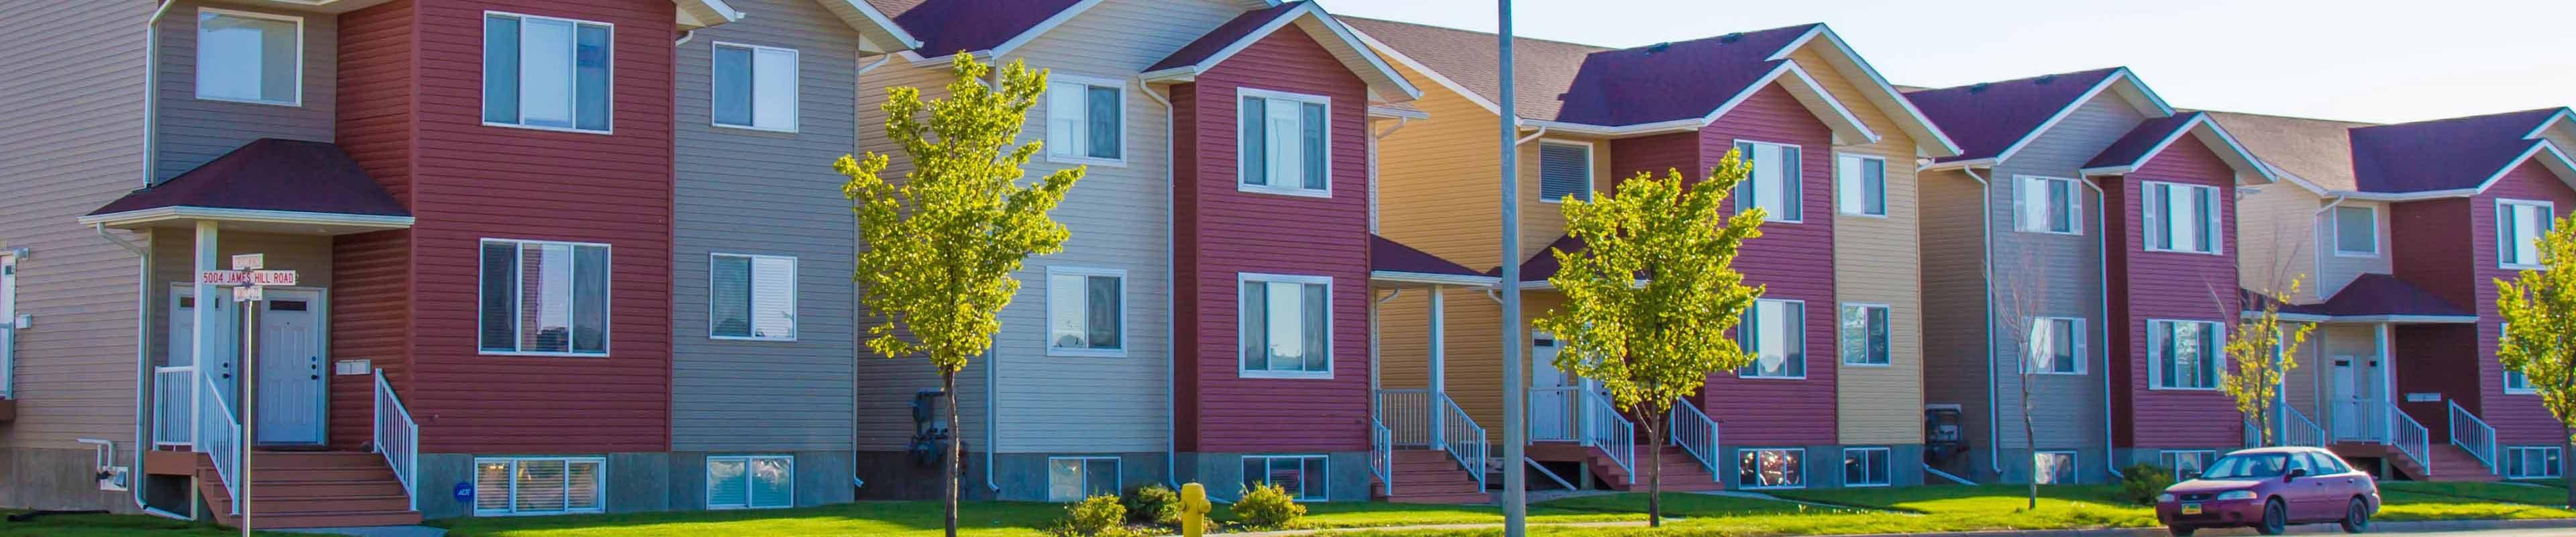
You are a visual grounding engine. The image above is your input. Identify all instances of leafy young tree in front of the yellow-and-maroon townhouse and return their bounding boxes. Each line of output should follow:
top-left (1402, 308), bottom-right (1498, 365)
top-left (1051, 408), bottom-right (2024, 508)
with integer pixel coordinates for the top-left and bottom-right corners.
top-left (1533, 155), bottom-right (1764, 527)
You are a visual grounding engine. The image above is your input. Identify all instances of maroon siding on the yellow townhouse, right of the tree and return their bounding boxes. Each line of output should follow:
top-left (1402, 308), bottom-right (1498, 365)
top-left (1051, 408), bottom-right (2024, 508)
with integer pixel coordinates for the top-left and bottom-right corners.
top-left (1693, 85), bottom-right (1842, 446)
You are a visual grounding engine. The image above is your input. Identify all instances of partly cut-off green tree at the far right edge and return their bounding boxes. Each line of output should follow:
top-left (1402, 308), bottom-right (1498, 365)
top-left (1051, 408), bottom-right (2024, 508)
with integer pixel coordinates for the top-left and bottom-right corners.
top-left (2496, 214), bottom-right (2576, 509)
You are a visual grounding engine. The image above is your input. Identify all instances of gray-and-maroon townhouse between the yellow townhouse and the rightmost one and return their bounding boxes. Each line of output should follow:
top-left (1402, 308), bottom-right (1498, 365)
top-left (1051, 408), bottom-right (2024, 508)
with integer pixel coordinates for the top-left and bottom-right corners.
top-left (1907, 67), bottom-right (2272, 483)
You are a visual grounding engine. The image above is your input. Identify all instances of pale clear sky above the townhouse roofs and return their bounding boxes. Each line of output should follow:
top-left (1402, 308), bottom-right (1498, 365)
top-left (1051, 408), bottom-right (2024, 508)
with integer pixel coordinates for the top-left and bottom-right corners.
top-left (1319, 0), bottom-right (2576, 121)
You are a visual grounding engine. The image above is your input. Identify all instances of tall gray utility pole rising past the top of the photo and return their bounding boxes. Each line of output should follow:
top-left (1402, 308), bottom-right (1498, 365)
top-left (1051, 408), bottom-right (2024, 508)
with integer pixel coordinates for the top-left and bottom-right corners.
top-left (1494, 0), bottom-right (1530, 537)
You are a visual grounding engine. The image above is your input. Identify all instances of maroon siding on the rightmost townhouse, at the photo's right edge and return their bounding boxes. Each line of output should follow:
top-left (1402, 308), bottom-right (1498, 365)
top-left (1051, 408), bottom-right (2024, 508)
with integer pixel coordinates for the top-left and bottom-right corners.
top-left (2460, 162), bottom-right (2576, 444)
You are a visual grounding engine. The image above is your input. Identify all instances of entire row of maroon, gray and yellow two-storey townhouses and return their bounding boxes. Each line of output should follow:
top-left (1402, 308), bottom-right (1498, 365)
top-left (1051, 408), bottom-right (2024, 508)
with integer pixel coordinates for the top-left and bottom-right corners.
top-left (0, 0), bottom-right (2576, 527)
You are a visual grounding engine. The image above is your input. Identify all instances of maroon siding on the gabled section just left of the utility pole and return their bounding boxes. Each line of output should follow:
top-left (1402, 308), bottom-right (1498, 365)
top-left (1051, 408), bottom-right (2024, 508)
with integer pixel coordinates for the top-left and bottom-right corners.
top-left (1172, 31), bottom-right (1371, 452)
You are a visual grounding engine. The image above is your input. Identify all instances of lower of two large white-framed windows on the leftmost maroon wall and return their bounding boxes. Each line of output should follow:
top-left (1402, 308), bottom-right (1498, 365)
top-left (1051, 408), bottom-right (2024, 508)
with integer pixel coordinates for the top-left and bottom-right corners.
top-left (474, 238), bottom-right (610, 356)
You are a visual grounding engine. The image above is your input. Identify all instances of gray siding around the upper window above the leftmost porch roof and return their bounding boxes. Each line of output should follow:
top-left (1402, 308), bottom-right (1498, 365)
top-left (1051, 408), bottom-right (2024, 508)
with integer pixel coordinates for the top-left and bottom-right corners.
top-left (154, 0), bottom-right (340, 181)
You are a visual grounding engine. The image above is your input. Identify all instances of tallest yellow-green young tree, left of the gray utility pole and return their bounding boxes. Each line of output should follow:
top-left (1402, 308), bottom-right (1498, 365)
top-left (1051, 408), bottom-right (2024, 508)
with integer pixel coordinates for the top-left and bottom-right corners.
top-left (832, 54), bottom-right (1085, 537)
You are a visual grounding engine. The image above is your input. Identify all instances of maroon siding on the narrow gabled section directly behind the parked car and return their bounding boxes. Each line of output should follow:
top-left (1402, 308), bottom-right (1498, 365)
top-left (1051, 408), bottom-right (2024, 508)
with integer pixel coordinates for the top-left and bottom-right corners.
top-left (2102, 142), bottom-right (2244, 449)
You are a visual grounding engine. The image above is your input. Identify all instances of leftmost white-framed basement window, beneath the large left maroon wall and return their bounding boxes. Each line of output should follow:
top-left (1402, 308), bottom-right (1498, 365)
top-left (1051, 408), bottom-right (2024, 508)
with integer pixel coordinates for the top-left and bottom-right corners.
top-left (474, 457), bottom-right (608, 516)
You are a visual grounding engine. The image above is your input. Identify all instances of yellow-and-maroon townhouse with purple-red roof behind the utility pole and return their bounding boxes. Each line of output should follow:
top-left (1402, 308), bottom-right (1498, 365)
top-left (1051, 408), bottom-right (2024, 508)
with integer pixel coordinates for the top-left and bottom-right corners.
top-left (1352, 18), bottom-right (1957, 491)
